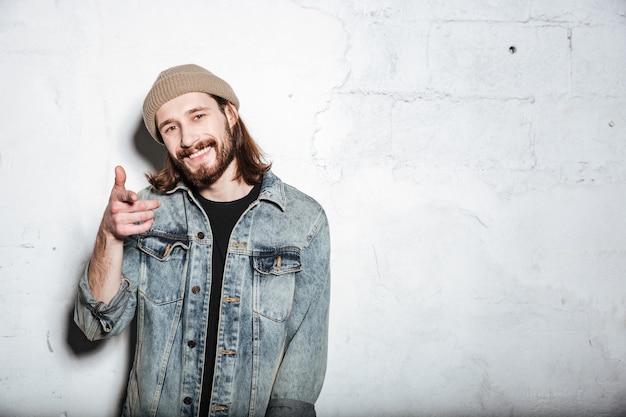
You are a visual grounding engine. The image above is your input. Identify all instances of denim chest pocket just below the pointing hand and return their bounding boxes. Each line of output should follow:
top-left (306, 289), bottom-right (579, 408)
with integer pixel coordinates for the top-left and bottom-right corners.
top-left (137, 235), bottom-right (189, 304)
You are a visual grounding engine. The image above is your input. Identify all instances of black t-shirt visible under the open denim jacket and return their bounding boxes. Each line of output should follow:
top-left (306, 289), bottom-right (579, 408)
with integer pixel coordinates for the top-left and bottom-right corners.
top-left (196, 184), bottom-right (261, 416)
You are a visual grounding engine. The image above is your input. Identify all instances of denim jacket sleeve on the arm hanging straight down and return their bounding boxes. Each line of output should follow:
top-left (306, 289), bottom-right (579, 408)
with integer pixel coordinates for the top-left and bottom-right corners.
top-left (266, 211), bottom-right (330, 417)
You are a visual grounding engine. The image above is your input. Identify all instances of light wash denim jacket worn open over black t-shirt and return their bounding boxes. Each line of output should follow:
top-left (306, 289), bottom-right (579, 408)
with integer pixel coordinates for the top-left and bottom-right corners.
top-left (74, 172), bottom-right (330, 417)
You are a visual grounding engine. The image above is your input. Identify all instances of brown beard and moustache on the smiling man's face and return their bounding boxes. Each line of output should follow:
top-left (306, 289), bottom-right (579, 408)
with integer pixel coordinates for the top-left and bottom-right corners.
top-left (172, 124), bottom-right (235, 190)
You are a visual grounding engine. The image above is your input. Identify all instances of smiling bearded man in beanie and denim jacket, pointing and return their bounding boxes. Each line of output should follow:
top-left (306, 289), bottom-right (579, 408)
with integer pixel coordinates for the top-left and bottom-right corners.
top-left (74, 65), bottom-right (330, 417)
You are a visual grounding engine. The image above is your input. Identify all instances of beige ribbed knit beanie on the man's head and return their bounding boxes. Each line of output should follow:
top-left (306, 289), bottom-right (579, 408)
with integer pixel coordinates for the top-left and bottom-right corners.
top-left (143, 64), bottom-right (239, 143)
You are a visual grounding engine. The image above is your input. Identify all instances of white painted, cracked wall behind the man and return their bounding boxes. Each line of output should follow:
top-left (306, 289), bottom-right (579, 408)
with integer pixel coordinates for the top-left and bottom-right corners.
top-left (0, 0), bottom-right (626, 417)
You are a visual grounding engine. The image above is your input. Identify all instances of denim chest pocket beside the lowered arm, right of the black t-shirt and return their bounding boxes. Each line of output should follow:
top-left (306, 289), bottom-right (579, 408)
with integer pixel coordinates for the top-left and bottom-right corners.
top-left (252, 248), bottom-right (302, 322)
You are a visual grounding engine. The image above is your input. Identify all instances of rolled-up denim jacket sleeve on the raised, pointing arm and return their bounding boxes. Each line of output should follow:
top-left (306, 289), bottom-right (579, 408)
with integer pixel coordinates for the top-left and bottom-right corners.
top-left (74, 238), bottom-right (137, 341)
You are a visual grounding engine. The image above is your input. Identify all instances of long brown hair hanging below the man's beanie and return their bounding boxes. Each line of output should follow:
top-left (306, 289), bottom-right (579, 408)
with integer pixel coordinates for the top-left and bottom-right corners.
top-left (146, 94), bottom-right (272, 193)
